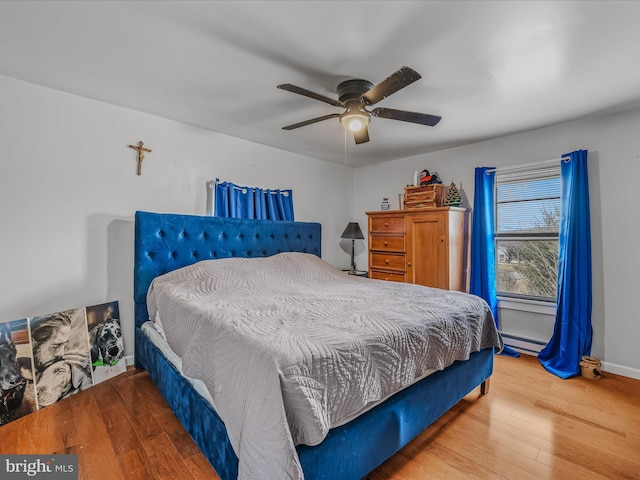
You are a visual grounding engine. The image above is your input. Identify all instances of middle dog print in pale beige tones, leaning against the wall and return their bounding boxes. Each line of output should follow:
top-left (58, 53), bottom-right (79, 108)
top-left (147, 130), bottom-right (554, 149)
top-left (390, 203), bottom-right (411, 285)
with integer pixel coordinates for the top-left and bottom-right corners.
top-left (29, 308), bottom-right (93, 408)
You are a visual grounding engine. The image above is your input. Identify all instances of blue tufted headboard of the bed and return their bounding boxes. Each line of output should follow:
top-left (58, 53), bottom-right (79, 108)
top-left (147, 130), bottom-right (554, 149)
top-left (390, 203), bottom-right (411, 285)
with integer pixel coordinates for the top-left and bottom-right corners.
top-left (133, 212), bottom-right (322, 327)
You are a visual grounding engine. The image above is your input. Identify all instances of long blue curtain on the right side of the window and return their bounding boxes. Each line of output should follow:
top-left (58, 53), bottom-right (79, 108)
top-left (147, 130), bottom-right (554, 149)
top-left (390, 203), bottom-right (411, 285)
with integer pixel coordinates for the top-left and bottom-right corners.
top-left (538, 150), bottom-right (593, 378)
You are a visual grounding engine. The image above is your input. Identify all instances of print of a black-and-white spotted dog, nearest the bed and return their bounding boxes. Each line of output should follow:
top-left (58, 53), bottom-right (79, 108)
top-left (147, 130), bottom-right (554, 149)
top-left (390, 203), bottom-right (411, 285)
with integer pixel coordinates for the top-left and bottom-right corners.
top-left (87, 302), bottom-right (127, 385)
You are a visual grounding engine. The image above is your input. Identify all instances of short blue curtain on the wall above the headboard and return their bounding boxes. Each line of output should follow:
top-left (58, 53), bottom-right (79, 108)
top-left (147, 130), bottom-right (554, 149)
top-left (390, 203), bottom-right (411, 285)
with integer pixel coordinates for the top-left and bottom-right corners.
top-left (214, 179), bottom-right (295, 221)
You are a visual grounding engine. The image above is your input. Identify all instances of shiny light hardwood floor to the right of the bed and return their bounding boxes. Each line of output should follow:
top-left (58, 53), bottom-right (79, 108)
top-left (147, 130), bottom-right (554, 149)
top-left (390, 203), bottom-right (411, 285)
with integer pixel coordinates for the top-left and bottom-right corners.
top-left (370, 355), bottom-right (640, 480)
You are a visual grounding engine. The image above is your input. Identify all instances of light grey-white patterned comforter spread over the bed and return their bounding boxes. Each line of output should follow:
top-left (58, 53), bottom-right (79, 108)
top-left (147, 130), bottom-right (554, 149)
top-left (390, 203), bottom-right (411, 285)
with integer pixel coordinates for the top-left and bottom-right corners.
top-left (147, 253), bottom-right (502, 480)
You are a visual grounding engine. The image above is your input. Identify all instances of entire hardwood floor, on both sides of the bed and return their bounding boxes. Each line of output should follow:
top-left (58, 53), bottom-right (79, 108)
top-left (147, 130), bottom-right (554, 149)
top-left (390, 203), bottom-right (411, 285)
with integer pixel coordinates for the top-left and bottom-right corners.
top-left (0, 355), bottom-right (640, 480)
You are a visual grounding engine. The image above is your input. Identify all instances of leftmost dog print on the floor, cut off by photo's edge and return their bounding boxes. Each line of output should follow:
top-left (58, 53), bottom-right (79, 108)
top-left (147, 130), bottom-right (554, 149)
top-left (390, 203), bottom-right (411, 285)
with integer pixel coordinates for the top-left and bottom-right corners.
top-left (0, 318), bottom-right (38, 426)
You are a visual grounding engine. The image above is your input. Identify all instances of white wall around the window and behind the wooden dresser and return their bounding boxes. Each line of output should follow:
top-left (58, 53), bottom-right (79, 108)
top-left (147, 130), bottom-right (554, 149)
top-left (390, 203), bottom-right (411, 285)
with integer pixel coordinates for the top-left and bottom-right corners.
top-left (354, 105), bottom-right (640, 378)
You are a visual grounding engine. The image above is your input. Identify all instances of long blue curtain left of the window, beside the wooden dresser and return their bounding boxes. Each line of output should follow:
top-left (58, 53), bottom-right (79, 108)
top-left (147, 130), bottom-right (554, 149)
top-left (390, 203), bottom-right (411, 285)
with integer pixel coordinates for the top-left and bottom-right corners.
top-left (469, 167), bottom-right (520, 357)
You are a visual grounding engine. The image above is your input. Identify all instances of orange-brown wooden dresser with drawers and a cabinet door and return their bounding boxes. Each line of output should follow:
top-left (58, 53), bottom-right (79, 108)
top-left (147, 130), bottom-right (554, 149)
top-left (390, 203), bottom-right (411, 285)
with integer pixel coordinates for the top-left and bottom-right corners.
top-left (367, 207), bottom-right (471, 292)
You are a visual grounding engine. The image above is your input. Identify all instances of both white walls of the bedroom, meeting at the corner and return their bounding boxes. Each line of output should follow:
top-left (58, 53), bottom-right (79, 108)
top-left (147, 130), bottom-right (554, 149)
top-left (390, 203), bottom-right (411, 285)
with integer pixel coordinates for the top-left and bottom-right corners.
top-left (6, 71), bottom-right (640, 378)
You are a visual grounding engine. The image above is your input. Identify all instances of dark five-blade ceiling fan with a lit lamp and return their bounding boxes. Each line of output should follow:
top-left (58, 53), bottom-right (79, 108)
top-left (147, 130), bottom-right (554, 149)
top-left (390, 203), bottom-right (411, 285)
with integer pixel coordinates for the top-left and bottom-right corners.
top-left (278, 67), bottom-right (442, 143)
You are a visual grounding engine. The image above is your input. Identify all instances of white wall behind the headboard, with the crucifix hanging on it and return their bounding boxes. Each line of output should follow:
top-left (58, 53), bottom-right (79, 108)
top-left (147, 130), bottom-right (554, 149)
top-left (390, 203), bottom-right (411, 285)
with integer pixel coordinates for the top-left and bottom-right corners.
top-left (0, 76), bottom-right (353, 364)
